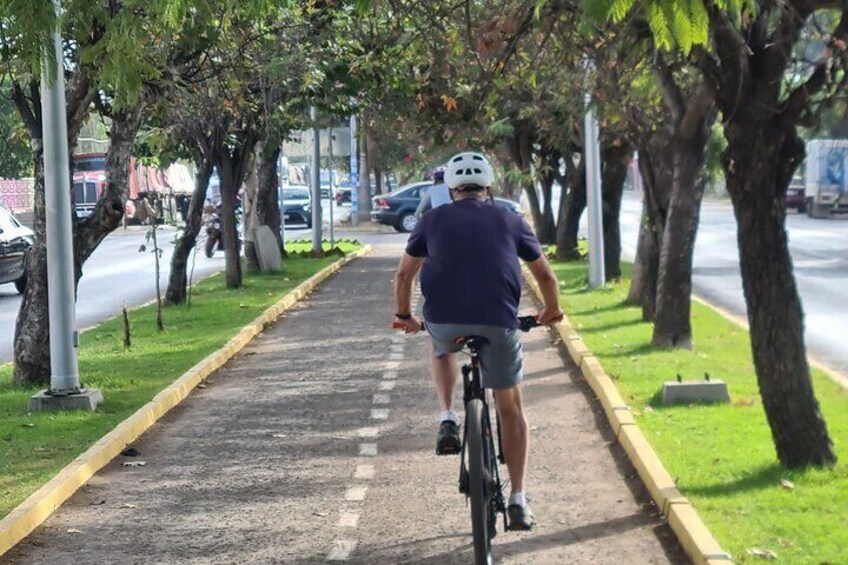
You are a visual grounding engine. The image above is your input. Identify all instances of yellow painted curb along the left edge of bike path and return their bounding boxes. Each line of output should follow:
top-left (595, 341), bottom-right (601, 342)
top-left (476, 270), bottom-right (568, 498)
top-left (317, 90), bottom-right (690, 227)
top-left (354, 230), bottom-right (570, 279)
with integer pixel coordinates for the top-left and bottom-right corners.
top-left (0, 245), bottom-right (371, 556)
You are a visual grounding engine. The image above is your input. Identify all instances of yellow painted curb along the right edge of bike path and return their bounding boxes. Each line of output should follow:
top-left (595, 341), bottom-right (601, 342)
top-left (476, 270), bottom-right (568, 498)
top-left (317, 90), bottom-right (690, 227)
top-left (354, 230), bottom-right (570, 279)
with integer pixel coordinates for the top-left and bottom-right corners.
top-left (522, 267), bottom-right (732, 565)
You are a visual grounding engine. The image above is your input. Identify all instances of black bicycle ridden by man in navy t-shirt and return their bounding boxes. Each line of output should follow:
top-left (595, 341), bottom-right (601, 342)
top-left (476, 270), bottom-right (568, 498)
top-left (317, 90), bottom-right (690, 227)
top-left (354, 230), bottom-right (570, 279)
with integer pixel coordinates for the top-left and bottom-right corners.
top-left (455, 316), bottom-right (539, 565)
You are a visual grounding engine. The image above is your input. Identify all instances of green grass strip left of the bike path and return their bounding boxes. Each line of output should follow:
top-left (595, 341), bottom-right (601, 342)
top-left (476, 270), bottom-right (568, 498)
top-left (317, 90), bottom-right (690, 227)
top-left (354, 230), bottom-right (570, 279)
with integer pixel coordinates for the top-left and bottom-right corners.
top-left (0, 243), bottom-right (358, 518)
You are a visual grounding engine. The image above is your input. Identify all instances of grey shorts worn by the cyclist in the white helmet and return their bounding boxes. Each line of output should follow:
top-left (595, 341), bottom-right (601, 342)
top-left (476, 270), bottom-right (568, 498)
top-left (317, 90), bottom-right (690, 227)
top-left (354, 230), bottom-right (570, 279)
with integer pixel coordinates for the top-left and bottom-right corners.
top-left (425, 322), bottom-right (524, 389)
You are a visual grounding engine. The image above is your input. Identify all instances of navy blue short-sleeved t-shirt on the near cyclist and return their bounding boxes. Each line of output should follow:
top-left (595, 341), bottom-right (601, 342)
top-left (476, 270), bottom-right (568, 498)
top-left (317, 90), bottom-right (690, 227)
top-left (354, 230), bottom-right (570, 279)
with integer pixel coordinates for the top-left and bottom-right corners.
top-left (406, 200), bottom-right (542, 328)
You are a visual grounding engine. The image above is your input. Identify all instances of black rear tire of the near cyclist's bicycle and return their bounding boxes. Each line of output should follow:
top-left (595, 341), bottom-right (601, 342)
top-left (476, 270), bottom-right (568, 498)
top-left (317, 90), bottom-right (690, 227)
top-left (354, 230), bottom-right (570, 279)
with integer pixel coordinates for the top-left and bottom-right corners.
top-left (465, 398), bottom-right (494, 565)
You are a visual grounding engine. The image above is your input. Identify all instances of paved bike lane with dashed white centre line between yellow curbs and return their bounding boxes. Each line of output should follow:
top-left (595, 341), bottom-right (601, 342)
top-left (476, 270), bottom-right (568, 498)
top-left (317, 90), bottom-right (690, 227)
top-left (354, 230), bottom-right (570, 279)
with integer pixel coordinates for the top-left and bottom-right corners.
top-left (0, 246), bottom-right (686, 564)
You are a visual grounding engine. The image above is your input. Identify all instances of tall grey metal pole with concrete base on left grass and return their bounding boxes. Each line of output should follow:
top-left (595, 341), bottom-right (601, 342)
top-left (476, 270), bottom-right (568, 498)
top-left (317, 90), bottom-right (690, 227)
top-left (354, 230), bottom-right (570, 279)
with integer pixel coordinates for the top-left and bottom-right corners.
top-left (29, 0), bottom-right (103, 411)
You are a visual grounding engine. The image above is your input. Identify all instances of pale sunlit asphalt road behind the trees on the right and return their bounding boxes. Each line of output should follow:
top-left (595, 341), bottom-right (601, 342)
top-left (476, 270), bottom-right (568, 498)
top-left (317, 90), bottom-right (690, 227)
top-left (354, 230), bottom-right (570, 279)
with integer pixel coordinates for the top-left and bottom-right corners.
top-left (621, 193), bottom-right (848, 372)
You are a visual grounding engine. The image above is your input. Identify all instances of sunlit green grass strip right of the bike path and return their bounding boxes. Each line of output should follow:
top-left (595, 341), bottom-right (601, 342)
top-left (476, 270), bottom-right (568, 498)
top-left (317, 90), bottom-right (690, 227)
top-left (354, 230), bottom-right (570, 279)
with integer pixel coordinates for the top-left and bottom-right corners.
top-left (554, 263), bottom-right (848, 565)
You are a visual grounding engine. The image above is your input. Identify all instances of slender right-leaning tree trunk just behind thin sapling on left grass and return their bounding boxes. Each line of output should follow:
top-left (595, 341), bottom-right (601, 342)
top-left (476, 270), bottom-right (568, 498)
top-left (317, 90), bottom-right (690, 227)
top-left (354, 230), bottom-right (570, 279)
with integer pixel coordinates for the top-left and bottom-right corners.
top-left (165, 156), bottom-right (213, 304)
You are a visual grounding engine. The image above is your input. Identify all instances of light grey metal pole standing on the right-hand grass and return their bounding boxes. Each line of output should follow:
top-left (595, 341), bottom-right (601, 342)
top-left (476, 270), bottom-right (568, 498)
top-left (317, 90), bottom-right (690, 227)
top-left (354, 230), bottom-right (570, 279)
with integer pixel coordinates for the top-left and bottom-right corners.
top-left (583, 90), bottom-right (606, 288)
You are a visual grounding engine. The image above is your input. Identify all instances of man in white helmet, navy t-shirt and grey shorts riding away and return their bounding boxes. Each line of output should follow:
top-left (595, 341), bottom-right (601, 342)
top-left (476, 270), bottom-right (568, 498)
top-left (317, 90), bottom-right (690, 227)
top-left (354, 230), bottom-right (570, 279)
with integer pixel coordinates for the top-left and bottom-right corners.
top-left (395, 153), bottom-right (562, 530)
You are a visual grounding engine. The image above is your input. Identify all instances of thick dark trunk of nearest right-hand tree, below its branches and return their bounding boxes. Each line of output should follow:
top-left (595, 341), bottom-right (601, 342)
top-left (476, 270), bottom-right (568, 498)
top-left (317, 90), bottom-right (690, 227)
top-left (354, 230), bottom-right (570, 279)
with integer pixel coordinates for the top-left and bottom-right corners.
top-left (722, 121), bottom-right (836, 467)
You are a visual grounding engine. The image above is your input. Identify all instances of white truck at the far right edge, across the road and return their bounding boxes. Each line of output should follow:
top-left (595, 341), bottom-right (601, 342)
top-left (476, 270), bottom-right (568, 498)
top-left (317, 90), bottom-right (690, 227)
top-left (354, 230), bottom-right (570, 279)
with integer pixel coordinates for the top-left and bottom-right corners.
top-left (804, 139), bottom-right (848, 218)
